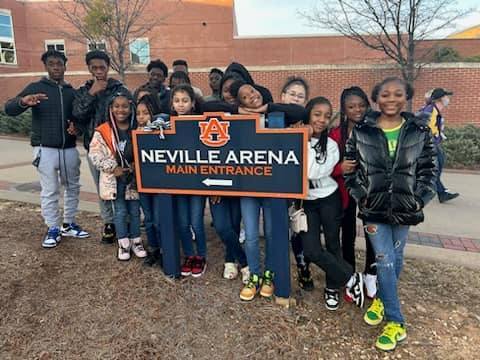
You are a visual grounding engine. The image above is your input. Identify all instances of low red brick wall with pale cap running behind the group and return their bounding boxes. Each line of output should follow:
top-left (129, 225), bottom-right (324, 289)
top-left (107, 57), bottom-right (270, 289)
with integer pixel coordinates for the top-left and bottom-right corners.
top-left (0, 63), bottom-right (480, 126)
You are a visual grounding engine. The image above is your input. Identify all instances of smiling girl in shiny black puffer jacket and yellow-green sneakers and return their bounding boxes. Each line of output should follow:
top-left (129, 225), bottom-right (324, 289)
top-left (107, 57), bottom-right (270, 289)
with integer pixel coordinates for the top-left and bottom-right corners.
top-left (345, 78), bottom-right (437, 350)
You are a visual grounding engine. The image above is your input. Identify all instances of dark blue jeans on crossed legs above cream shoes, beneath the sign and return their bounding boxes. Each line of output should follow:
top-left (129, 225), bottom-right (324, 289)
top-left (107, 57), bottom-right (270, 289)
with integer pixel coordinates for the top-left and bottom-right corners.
top-left (210, 197), bottom-right (247, 267)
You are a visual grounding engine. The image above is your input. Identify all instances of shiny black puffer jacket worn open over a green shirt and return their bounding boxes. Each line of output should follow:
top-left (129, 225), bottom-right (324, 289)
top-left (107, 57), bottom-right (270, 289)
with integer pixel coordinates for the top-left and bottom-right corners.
top-left (345, 113), bottom-right (437, 225)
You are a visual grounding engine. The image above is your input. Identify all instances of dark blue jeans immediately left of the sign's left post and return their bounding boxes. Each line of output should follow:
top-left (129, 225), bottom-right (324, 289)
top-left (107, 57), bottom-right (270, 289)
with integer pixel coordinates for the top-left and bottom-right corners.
top-left (140, 193), bottom-right (162, 249)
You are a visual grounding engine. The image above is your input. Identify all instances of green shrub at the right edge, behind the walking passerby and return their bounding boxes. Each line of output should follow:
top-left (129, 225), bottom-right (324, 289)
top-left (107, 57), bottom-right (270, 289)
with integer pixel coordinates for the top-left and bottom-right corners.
top-left (442, 125), bottom-right (480, 169)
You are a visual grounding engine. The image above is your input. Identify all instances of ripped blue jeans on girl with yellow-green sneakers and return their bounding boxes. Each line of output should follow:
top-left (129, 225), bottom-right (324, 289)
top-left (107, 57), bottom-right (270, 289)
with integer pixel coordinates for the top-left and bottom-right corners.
top-left (365, 221), bottom-right (409, 324)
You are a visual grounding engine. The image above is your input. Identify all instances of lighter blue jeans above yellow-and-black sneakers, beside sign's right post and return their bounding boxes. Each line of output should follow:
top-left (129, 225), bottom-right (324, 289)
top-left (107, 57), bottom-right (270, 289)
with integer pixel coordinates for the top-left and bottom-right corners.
top-left (240, 197), bottom-right (273, 276)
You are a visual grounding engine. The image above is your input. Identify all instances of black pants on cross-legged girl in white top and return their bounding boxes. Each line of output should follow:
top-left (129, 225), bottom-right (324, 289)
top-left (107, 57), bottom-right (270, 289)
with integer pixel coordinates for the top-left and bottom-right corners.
top-left (300, 190), bottom-right (353, 289)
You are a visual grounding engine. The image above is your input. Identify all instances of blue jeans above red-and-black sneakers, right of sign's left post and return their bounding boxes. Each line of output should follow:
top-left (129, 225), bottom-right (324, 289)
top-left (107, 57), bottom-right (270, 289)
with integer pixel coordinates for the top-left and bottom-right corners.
top-left (176, 195), bottom-right (207, 257)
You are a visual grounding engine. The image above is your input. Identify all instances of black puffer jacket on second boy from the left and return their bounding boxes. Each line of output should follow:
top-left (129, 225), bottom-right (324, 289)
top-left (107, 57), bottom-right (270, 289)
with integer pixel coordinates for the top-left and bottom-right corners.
top-left (73, 78), bottom-right (131, 150)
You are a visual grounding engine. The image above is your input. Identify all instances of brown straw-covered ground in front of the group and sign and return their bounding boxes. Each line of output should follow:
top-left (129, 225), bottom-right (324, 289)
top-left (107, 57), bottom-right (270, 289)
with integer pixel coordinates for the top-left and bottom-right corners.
top-left (0, 201), bottom-right (480, 360)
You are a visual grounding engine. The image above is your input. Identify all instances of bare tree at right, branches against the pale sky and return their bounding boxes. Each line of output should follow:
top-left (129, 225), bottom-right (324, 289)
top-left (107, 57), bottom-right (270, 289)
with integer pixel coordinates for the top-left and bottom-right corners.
top-left (300, 0), bottom-right (470, 108)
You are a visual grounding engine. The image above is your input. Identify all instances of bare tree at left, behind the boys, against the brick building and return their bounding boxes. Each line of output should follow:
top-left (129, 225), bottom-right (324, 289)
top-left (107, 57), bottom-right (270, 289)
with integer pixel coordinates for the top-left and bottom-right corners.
top-left (55, 0), bottom-right (180, 80)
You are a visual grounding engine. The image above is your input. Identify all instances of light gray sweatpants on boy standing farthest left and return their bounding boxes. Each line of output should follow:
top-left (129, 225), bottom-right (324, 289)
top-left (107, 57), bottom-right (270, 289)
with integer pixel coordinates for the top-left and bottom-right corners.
top-left (33, 146), bottom-right (80, 227)
